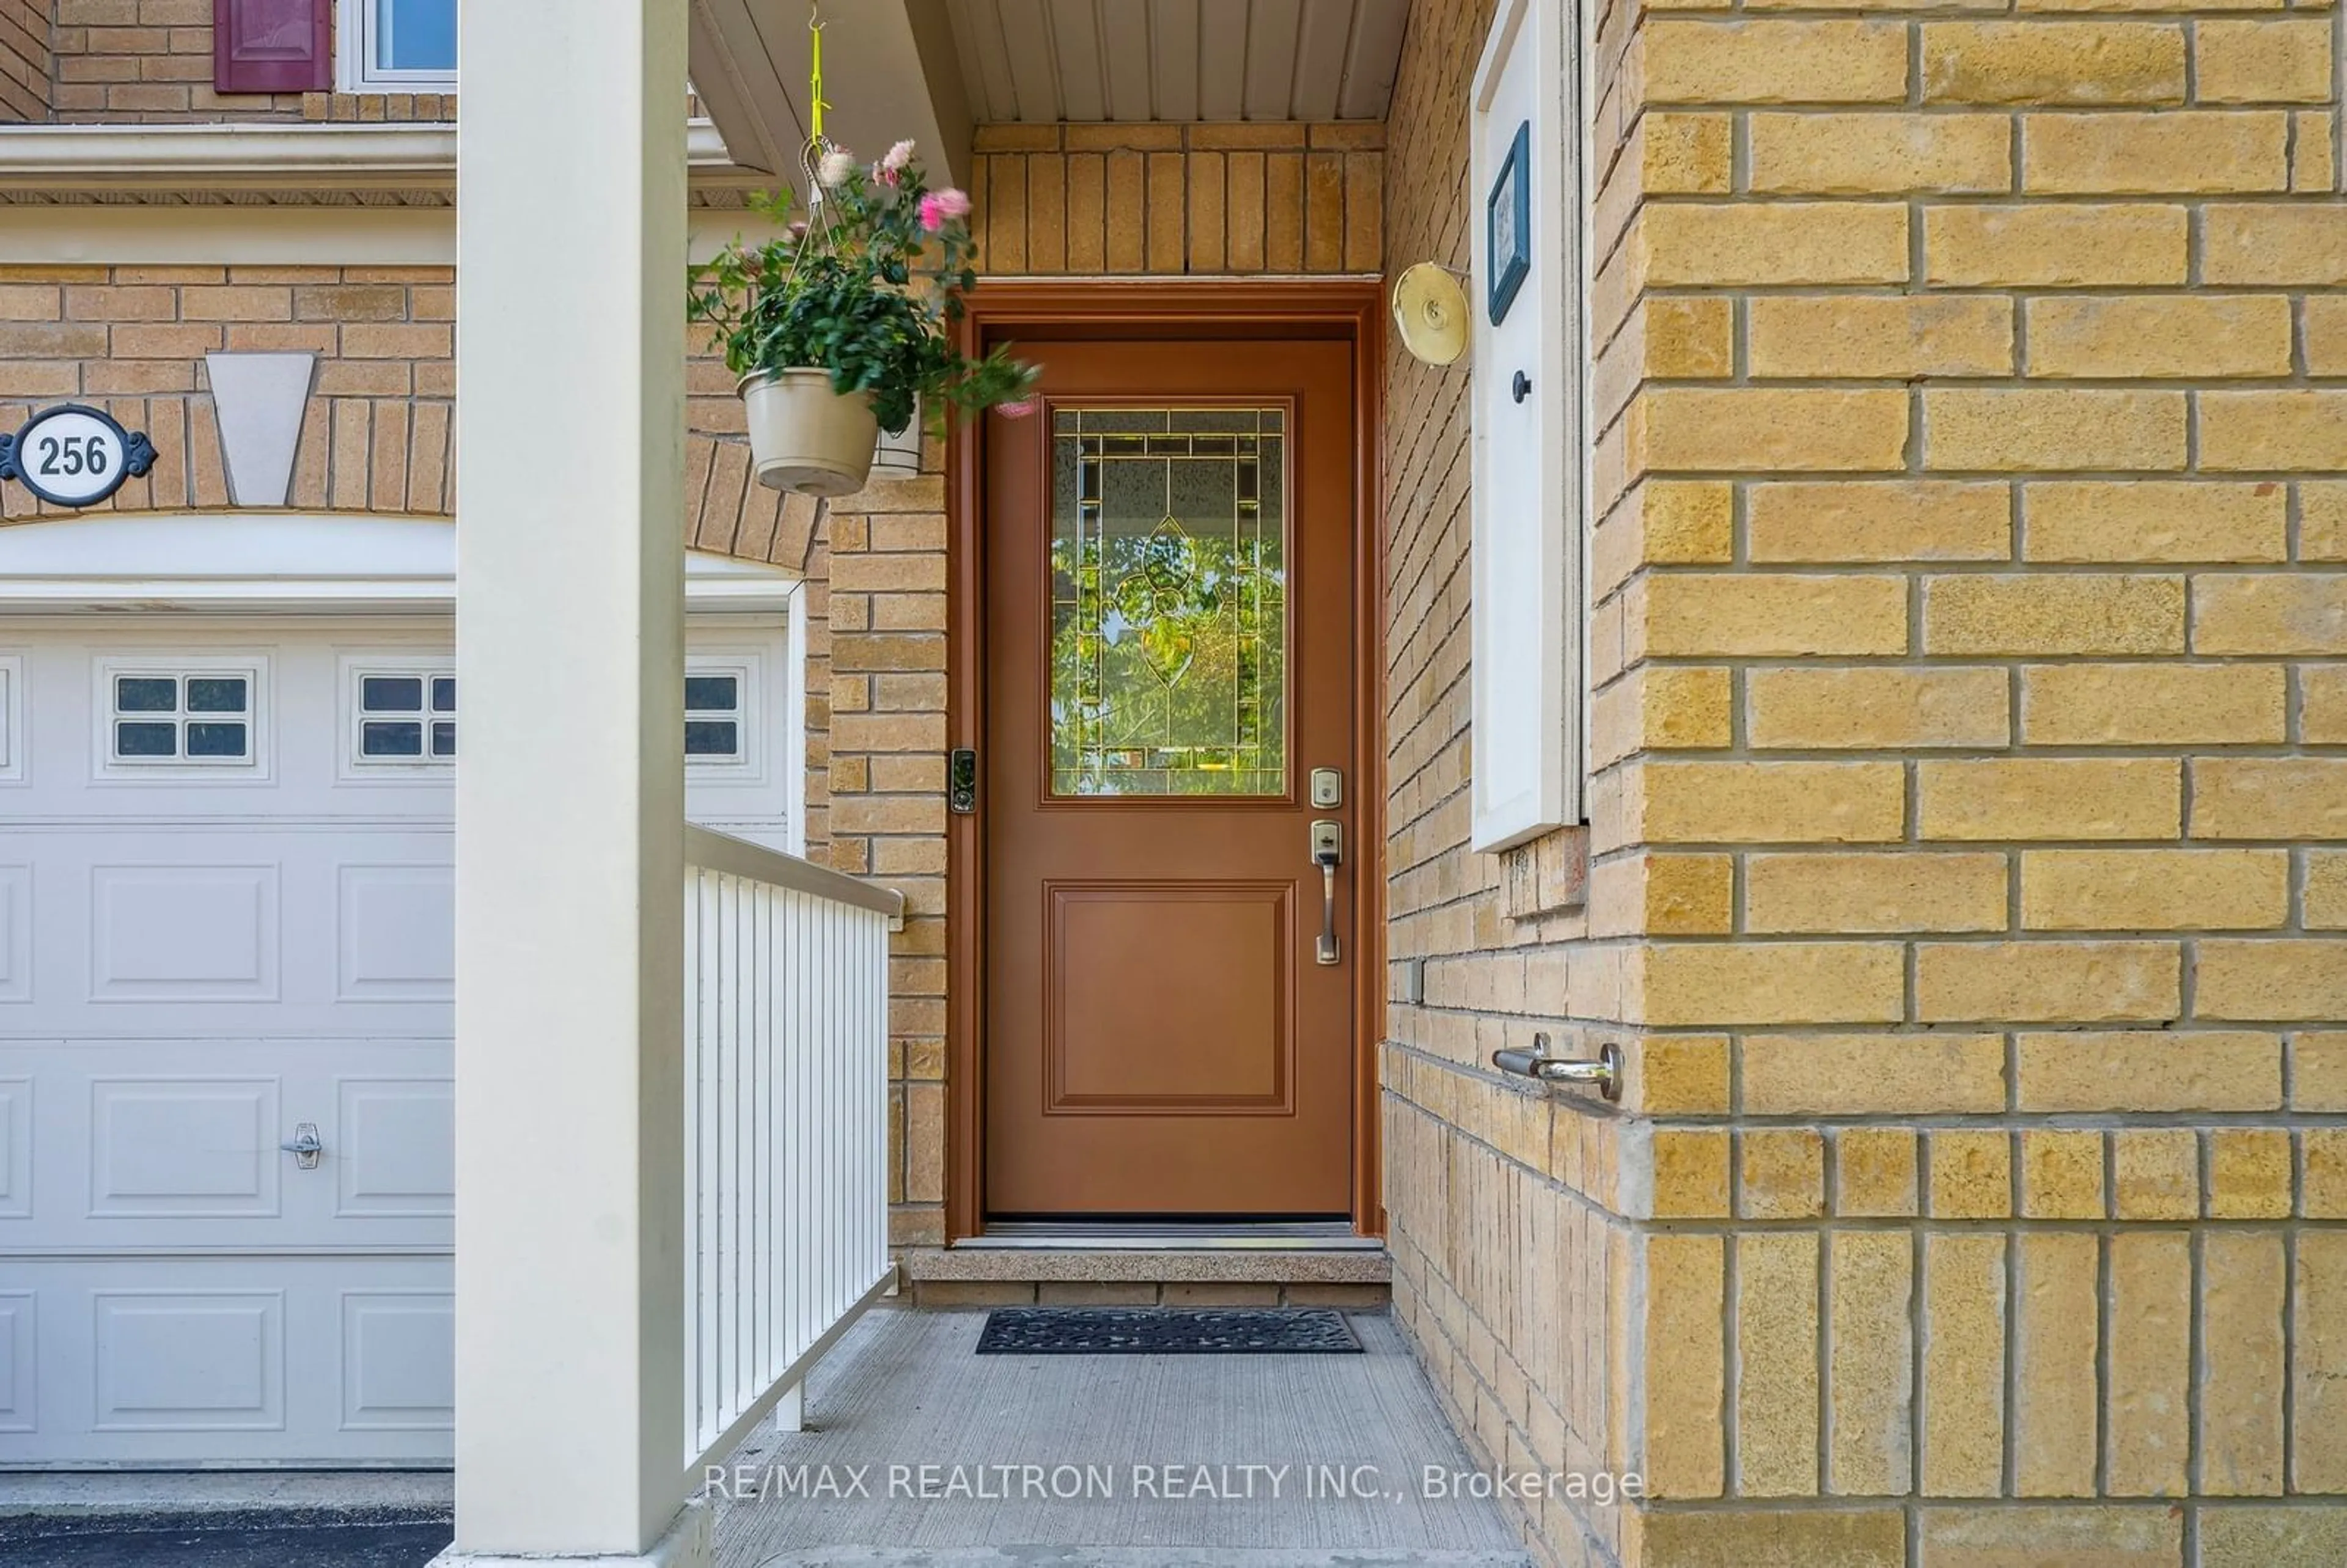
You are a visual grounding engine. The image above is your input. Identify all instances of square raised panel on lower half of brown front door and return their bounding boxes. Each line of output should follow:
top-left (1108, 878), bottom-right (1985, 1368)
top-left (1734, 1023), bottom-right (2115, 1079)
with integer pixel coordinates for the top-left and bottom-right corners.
top-left (1045, 882), bottom-right (1296, 1115)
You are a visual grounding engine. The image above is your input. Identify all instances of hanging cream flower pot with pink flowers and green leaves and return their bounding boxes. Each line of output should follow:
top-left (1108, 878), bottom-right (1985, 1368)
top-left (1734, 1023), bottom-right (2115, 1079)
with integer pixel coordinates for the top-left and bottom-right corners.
top-left (685, 141), bottom-right (1035, 497)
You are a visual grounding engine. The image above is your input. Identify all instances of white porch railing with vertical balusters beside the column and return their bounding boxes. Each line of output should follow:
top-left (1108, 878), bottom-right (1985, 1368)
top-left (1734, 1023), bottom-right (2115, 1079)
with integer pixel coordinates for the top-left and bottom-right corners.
top-left (685, 829), bottom-right (903, 1479)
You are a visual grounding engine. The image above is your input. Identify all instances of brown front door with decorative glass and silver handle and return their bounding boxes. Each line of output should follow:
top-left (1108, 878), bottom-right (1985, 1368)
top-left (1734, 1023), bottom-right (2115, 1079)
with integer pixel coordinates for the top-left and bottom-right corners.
top-left (981, 340), bottom-right (1361, 1218)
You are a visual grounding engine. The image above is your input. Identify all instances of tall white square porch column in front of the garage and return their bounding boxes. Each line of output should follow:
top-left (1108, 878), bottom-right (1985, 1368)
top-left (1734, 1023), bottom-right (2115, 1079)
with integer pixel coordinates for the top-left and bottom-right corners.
top-left (450, 0), bottom-right (685, 1561)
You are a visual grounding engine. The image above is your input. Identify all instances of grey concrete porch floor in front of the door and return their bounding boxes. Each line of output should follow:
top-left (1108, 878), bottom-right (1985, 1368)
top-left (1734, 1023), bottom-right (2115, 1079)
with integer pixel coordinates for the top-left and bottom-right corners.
top-left (711, 1308), bottom-right (1530, 1568)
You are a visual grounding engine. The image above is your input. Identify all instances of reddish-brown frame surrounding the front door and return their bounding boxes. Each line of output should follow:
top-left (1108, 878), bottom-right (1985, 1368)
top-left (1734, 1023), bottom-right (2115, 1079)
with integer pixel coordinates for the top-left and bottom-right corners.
top-left (946, 277), bottom-right (1385, 1247)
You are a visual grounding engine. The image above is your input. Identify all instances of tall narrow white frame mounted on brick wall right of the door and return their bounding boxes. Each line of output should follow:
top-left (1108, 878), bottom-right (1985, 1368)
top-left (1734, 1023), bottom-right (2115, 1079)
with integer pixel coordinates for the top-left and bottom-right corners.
top-left (1467, 0), bottom-right (1589, 850)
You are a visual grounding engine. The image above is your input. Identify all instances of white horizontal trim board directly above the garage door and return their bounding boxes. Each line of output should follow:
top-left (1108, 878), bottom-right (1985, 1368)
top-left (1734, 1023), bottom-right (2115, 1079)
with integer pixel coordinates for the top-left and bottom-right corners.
top-left (0, 511), bottom-right (798, 615)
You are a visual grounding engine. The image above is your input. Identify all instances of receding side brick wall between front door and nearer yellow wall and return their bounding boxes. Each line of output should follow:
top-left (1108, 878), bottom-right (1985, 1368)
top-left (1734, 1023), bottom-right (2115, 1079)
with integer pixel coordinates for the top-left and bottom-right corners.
top-left (1383, 0), bottom-right (1661, 1563)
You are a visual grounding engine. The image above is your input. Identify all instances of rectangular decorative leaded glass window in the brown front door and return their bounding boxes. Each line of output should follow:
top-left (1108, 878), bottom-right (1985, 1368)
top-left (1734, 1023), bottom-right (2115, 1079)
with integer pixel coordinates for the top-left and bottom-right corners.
top-left (1051, 408), bottom-right (1288, 796)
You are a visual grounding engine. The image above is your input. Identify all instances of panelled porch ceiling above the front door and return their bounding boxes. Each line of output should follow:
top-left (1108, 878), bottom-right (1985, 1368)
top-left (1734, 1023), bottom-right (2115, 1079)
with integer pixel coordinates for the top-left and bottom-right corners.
top-left (946, 0), bottom-right (1408, 122)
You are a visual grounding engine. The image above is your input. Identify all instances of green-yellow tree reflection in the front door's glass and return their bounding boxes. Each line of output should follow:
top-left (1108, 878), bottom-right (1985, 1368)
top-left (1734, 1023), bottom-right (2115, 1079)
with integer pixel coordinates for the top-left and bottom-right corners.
top-left (1051, 516), bottom-right (1286, 796)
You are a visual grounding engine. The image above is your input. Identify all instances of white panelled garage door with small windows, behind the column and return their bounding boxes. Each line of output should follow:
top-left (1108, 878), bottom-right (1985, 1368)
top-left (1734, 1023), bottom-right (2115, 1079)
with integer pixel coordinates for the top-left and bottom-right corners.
top-left (0, 615), bottom-right (800, 1465)
